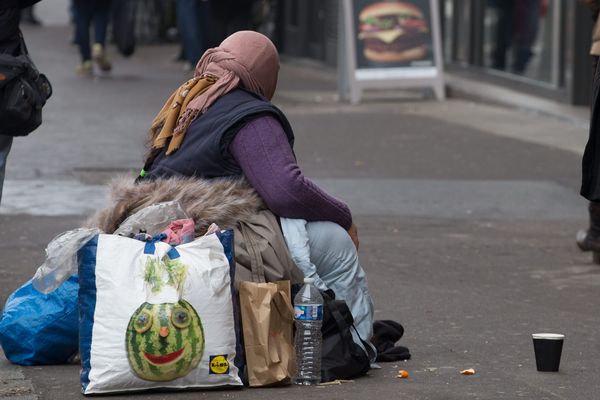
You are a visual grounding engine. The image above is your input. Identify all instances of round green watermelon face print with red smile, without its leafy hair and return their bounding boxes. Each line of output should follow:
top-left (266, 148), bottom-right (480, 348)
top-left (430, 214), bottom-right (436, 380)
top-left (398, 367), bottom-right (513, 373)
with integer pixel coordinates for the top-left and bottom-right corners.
top-left (126, 300), bottom-right (204, 381)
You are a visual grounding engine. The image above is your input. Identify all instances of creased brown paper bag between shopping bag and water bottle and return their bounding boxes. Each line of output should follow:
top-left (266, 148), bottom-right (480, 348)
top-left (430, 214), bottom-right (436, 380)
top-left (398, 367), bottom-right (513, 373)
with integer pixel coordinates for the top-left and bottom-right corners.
top-left (239, 281), bottom-right (296, 386)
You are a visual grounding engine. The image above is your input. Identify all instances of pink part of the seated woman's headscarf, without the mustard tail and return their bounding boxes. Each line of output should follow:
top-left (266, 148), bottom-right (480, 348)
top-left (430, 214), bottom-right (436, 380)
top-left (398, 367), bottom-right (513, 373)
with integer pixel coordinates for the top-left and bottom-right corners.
top-left (174, 31), bottom-right (279, 134)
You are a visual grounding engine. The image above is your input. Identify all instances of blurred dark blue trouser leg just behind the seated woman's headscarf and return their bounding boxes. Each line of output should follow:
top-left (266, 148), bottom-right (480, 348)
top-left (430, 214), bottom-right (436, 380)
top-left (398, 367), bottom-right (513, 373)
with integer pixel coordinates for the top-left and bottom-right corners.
top-left (177, 0), bottom-right (210, 67)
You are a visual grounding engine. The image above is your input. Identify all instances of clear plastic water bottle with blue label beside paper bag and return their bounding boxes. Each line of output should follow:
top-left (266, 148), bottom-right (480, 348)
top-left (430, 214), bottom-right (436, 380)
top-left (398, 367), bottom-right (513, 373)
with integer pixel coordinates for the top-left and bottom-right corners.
top-left (294, 278), bottom-right (323, 385)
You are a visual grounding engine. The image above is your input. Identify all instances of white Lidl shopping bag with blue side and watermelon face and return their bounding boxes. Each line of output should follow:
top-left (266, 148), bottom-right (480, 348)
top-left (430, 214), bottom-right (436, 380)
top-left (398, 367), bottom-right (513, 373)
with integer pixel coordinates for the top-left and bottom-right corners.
top-left (78, 234), bottom-right (242, 394)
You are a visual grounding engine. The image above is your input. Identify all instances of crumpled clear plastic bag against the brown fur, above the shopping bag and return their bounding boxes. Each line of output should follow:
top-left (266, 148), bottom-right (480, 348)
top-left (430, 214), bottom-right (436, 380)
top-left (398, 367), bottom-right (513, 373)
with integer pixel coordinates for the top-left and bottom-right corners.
top-left (113, 201), bottom-right (189, 236)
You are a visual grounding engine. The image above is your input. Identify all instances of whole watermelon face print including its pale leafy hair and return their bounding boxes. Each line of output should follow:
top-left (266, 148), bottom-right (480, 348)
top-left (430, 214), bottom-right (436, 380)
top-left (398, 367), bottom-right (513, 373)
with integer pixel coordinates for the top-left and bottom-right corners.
top-left (125, 251), bottom-right (205, 381)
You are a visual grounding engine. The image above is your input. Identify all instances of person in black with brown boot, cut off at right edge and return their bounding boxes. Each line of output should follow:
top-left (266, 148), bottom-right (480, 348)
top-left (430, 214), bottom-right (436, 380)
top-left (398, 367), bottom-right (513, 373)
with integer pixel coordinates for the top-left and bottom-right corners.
top-left (575, 0), bottom-right (600, 264)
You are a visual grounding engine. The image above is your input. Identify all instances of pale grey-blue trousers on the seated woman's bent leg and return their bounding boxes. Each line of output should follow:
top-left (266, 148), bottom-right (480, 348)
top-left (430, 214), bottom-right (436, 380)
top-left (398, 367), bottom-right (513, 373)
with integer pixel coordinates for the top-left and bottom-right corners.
top-left (281, 218), bottom-right (376, 362)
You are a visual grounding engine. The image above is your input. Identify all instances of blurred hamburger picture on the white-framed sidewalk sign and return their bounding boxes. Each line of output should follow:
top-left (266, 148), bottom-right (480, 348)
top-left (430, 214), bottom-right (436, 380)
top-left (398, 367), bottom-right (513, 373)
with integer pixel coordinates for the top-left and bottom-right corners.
top-left (358, 1), bottom-right (429, 63)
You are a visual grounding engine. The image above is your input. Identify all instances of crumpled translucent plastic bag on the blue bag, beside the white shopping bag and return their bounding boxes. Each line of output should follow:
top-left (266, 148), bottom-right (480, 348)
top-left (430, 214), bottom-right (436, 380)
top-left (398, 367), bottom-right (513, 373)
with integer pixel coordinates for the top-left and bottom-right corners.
top-left (31, 228), bottom-right (101, 294)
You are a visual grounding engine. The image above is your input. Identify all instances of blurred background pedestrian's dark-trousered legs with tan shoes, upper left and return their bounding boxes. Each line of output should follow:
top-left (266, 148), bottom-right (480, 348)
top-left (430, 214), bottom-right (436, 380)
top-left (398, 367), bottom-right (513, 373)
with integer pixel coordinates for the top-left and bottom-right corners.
top-left (73, 0), bottom-right (112, 77)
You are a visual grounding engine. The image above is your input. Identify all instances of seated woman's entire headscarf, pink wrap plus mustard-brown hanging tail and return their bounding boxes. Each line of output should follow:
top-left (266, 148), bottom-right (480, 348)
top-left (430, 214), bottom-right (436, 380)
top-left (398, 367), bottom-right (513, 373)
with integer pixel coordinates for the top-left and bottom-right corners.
top-left (149, 31), bottom-right (279, 155)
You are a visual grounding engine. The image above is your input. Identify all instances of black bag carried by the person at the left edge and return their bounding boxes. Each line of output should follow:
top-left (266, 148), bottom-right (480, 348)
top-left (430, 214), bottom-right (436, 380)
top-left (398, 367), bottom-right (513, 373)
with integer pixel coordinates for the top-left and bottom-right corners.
top-left (0, 32), bottom-right (52, 136)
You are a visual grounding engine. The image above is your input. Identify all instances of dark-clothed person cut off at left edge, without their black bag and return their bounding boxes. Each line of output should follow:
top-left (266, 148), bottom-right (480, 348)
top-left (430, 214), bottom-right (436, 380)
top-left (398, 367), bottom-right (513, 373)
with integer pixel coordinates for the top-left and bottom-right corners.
top-left (0, 0), bottom-right (40, 200)
